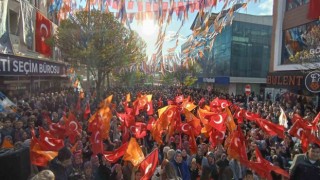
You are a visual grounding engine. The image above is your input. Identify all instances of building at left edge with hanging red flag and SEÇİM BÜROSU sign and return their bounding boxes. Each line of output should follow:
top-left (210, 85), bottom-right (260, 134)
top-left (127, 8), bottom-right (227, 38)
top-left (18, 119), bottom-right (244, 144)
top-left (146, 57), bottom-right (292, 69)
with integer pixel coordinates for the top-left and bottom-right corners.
top-left (0, 0), bottom-right (68, 95)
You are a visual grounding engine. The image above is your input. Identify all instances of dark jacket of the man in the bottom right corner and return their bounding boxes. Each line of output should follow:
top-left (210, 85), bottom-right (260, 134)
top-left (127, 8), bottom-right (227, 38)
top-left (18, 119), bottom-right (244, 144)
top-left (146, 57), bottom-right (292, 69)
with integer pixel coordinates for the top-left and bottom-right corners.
top-left (289, 154), bottom-right (320, 180)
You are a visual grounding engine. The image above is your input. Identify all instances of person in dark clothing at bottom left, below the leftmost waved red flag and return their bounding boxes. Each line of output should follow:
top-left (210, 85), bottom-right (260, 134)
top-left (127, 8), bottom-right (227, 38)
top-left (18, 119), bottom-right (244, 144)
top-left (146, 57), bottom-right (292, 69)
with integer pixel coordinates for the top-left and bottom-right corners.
top-left (49, 146), bottom-right (72, 180)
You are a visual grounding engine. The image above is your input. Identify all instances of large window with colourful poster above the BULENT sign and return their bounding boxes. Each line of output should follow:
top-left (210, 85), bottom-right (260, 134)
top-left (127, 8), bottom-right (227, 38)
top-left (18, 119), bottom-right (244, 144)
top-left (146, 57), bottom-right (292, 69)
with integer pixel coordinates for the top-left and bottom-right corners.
top-left (281, 21), bottom-right (320, 64)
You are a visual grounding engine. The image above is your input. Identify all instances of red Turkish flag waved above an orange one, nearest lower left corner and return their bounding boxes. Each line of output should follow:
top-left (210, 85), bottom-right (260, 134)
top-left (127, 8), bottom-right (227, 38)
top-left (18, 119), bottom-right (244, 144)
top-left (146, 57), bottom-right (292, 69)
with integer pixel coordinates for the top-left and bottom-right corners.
top-left (39, 127), bottom-right (64, 151)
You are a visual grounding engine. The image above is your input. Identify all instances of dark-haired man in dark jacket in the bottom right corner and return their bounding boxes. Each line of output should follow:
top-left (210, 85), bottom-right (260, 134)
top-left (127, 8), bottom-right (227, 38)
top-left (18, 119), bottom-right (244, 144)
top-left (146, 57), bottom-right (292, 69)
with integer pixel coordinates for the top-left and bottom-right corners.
top-left (289, 143), bottom-right (320, 180)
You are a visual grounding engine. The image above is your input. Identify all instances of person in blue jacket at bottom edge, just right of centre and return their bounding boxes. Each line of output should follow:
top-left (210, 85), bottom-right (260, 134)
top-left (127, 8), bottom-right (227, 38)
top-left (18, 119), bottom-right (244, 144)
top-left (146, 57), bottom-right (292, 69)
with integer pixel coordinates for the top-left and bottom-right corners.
top-left (173, 150), bottom-right (191, 180)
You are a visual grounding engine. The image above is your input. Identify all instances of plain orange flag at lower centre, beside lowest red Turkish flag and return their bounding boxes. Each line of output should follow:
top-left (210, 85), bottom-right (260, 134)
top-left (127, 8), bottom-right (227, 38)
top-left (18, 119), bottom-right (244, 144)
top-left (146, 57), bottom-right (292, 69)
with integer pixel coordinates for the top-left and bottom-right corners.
top-left (123, 138), bottom-right (144, 166)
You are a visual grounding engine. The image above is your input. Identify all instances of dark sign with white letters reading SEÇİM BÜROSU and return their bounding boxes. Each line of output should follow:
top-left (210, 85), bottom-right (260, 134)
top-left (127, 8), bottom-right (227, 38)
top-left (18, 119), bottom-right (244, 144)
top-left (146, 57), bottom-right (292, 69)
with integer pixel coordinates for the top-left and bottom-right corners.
top-left (0, 55), bottom-right (66, 76)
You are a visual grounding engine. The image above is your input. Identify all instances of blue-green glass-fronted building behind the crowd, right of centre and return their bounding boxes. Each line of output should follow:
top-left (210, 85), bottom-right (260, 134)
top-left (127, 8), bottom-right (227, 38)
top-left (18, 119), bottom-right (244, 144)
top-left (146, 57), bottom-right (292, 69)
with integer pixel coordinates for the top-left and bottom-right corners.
top-left (190, 13), bottom-right (272, 94)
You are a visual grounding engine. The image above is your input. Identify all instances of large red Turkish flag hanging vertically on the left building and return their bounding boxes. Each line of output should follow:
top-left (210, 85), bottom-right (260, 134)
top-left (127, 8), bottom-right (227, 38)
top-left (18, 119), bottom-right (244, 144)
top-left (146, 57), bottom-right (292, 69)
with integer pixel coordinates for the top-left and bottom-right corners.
top-left (35, 11), bottom-right (52, 57)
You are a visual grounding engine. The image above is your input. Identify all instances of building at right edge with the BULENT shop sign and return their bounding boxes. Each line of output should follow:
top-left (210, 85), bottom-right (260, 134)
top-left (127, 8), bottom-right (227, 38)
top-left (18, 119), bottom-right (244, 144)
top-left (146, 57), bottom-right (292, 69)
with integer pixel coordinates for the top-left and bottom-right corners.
top-left (266, 0), bottom-right (320, 102)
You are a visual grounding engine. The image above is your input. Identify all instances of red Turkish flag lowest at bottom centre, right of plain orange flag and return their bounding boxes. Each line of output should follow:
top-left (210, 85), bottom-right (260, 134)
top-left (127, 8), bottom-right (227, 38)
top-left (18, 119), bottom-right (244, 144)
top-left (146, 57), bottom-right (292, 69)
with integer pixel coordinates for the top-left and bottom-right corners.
top-left (140, 148), bottom-right (159, 180)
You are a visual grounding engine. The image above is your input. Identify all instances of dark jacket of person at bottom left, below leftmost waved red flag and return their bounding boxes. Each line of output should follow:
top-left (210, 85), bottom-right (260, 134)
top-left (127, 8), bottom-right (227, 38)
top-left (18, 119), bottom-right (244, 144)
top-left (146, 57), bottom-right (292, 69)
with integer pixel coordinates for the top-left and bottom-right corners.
top-left (49, 157), bottom-right (71, 180)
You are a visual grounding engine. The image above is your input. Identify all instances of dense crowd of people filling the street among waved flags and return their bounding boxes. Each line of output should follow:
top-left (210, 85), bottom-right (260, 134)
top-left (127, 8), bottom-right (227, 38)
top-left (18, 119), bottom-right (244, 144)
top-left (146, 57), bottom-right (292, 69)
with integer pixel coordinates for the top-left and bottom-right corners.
top-left (0, 86), bottom-right (320, 180)
